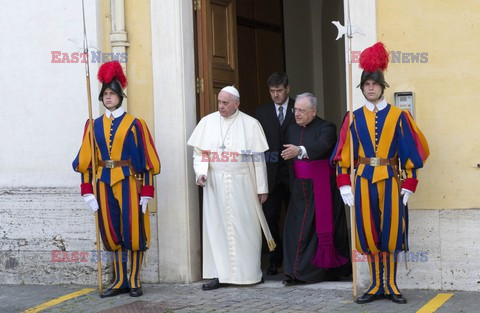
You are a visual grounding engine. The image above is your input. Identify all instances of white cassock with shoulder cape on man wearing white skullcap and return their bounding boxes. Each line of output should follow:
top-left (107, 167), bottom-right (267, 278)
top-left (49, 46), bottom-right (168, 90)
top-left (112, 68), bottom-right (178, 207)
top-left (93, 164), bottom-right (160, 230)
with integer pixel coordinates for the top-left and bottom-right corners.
top-left (188, 110), bottom-right (268, 284)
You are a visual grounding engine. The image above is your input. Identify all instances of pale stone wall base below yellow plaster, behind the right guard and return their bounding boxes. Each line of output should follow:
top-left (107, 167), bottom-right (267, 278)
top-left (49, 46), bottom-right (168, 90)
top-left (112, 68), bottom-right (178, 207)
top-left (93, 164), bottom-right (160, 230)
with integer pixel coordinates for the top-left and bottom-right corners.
top-left (357, 209), bottom-right (480, 291)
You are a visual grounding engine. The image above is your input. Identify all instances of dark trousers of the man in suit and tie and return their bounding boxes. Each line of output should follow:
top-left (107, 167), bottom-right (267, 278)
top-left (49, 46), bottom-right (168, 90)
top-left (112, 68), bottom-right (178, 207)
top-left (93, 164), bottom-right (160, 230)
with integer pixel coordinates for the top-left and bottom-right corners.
top-left (263, 176), bottom-right (290, 266)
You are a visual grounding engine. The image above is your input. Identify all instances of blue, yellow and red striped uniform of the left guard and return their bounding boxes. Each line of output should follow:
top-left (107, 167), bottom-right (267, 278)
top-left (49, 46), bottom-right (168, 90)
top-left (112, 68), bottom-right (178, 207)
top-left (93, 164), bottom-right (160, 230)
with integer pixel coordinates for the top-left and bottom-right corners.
top-left (73, 113), bottom-right (160, 288)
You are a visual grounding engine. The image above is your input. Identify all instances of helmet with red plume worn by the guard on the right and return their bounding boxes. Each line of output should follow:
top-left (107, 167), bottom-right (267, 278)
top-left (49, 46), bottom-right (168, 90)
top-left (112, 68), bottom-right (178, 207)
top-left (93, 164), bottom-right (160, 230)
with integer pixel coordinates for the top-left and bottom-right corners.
top-left (357, 42), bottom-right (390, 91)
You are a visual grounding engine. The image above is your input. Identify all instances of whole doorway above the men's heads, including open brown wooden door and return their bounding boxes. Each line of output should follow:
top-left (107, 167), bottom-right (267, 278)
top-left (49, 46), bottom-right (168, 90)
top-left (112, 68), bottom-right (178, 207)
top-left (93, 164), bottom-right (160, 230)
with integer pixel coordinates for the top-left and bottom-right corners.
top-left (195, 0), bottom-right (347, 127)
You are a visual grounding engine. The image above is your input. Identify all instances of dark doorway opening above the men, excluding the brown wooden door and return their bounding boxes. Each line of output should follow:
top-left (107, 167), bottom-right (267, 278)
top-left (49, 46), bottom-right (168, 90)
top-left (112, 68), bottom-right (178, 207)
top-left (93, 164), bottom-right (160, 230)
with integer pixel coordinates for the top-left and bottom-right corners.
top-left (236, 0), bottom-right (346, 127)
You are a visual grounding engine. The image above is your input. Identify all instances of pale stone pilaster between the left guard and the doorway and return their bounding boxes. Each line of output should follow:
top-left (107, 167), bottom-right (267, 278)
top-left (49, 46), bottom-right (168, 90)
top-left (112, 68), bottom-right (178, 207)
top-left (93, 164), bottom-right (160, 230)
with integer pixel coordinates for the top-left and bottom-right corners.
top-left (151, 0), bottom-right (201, 282)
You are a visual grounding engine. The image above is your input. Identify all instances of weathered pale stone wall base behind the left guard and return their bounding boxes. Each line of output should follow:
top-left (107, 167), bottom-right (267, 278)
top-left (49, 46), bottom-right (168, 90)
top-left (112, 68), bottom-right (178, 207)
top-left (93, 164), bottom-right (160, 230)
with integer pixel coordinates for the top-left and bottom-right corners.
top-left (0, 188), bottom-right (158, 285)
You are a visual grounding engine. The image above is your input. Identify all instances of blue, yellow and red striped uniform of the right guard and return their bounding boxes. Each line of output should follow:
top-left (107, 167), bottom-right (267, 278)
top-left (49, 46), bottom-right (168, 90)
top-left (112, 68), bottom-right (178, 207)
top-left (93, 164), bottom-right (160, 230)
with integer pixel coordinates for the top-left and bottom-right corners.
top-left (332, 104), bottom-right (429, 294)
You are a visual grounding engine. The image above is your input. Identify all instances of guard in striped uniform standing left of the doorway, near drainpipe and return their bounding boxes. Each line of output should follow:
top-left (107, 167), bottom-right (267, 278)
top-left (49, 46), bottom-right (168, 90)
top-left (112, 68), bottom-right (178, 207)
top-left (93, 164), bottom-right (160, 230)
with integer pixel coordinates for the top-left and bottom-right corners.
top-left (73, 61), bottom-right (160, 298)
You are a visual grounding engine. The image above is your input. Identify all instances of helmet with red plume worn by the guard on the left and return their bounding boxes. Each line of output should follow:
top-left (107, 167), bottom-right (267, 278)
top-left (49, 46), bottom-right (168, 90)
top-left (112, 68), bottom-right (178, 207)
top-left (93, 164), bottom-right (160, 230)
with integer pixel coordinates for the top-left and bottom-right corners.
top-left (97, 61), bottom-right (127, 109)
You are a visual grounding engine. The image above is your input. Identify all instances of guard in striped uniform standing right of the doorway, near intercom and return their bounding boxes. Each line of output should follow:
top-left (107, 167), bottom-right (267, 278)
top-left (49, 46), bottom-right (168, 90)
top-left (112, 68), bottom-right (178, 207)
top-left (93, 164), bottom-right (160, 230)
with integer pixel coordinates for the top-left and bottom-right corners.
top-left (332, 42), bottom-right (430, 304)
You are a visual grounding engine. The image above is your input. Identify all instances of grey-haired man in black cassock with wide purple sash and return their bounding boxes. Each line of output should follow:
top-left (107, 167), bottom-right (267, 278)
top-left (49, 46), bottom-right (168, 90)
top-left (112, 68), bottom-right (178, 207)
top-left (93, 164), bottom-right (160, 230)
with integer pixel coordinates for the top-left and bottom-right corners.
top-left (282, 93), bottom-right (351, 285)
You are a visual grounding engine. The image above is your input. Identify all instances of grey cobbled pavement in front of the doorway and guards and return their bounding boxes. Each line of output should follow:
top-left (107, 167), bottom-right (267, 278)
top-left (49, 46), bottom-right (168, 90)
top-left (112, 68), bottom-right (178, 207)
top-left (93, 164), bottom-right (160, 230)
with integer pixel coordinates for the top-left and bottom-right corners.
top-left (0, 280), bottom-right (480, 313)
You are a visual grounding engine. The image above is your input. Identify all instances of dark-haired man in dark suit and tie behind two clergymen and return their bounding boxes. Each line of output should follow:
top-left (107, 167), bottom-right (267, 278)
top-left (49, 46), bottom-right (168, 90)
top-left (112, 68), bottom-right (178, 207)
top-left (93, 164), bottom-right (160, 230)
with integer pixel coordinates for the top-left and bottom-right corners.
top-left (255, 72), bottom-right (295, 275)
